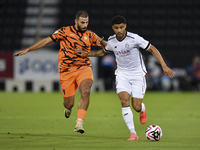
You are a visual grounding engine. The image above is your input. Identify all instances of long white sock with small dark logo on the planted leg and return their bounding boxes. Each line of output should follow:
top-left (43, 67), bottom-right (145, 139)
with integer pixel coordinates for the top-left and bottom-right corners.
top-left (122, 106), bottom-right (136, 133)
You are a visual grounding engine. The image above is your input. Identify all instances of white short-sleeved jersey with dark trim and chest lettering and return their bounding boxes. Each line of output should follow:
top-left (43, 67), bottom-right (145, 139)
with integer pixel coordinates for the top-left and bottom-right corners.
top-left (104, 32), bottom-right (150, 75)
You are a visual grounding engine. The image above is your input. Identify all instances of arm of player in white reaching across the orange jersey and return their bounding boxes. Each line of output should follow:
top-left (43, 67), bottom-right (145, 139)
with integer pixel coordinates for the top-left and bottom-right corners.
top-left (75, 48), bottom-right (108, 57)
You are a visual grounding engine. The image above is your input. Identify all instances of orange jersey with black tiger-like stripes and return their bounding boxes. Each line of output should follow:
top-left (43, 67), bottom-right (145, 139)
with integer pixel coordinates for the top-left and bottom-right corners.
top-left (50, 26), bottom-right (100, 73)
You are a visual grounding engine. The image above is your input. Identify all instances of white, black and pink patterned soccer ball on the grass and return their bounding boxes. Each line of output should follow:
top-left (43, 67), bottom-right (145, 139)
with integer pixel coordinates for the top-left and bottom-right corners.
top-left (145, 125), bottom-right (163, 141)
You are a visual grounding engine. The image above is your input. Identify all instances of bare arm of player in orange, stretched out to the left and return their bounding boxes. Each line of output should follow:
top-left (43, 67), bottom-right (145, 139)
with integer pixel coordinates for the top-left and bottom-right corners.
top-left (14, 37), bottom-right (53, 57)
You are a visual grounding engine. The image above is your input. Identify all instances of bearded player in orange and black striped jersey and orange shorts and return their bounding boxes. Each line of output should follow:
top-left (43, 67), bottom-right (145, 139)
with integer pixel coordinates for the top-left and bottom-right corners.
top-left (14, 11), bottom-right (103, 133)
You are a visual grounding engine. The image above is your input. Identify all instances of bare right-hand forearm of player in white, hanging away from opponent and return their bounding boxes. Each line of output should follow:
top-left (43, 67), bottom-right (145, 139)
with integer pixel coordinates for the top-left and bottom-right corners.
top-left (147, 45), bottom-right (174, 78)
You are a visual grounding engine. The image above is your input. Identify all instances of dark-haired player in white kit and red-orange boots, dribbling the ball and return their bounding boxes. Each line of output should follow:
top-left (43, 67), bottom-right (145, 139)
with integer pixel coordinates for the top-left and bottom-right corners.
top-left (75, 15), bottom-right (174, 141)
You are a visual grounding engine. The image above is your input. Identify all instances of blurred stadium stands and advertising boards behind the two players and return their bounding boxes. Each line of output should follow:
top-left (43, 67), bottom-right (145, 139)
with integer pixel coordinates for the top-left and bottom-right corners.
top-left (0, 0), bottom-right (200, 92)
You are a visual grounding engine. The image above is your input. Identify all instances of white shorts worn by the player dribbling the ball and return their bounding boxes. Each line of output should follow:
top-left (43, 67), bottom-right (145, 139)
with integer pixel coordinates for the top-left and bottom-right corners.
top-left (116, 72), bottom-right (146, 99)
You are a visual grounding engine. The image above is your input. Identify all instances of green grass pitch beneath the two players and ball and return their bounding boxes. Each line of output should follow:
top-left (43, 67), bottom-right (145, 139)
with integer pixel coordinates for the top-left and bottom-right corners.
top-left (0, 91), bottom-right (200, 150)
